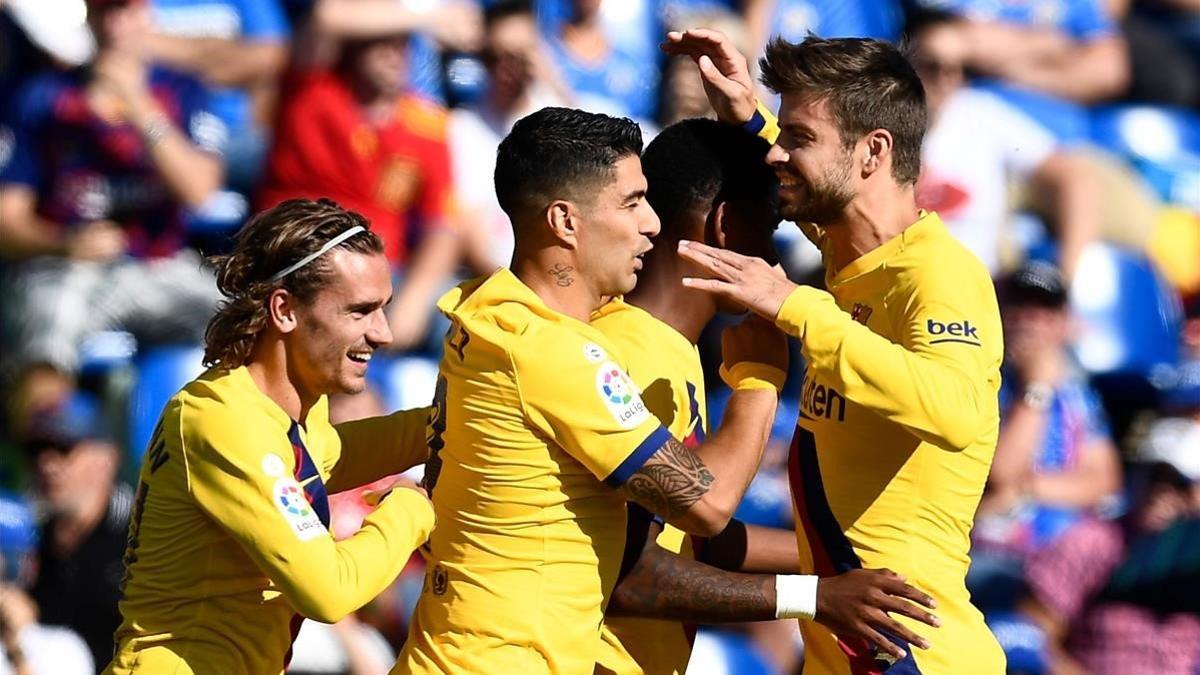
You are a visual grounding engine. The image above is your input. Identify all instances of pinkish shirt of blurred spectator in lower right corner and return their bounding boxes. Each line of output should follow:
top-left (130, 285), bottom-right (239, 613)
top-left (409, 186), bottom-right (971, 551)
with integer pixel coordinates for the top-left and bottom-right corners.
top-left (1026, 520), bottom-right (1200, 675)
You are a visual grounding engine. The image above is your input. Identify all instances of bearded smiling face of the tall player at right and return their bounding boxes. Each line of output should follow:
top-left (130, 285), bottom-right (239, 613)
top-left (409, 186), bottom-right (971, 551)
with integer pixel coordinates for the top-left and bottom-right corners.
top-left (767, 94), bottom-right (854, 225)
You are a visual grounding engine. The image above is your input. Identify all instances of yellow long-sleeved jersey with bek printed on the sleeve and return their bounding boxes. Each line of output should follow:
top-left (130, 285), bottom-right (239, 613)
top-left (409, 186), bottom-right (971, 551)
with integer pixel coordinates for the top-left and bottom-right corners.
top-left (760, 107), bottom-right (1004, 675)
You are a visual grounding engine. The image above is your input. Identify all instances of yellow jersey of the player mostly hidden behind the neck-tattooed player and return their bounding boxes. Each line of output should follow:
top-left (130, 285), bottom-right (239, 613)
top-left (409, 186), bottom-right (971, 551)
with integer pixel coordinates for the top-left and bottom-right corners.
top-left (592, 299), bottom-right (707, 675)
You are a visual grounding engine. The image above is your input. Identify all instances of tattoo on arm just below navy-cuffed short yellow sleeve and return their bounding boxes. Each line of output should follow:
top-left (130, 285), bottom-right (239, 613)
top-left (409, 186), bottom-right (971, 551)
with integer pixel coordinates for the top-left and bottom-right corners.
top-left (625, 438), bottom-right (713, 520)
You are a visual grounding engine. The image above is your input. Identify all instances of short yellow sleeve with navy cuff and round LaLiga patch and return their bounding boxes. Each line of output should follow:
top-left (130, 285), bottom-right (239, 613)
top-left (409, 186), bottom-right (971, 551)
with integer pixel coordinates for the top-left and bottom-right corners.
top-left (512, 339), bottom-right (671, 488)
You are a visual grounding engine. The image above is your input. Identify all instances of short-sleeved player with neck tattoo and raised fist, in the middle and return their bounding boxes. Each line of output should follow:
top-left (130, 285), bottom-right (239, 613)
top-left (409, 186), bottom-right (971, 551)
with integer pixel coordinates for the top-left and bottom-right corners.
top-left (396, 108), bottom-right (787, 674)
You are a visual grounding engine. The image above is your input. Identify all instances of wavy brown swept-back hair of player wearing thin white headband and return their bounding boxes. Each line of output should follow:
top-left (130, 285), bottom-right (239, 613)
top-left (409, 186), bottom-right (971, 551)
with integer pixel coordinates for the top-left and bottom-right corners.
top-left (204, 199), bottom-right (383, 370)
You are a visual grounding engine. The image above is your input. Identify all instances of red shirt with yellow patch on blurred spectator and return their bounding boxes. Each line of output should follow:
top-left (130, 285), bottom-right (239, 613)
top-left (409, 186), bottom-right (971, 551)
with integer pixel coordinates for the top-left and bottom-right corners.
top-left (259, 71), bottom-right (455, 265)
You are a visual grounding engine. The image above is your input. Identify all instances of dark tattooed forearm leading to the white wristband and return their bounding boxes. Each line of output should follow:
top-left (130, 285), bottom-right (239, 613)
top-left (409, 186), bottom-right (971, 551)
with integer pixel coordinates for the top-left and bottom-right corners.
top-left (606, 540), bottom-right (775, 623)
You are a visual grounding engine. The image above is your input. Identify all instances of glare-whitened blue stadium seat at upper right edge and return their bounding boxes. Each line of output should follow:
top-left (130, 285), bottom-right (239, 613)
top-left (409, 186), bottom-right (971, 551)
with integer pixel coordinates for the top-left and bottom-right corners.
top-left (1091, 104), bottom-right (1200, 209)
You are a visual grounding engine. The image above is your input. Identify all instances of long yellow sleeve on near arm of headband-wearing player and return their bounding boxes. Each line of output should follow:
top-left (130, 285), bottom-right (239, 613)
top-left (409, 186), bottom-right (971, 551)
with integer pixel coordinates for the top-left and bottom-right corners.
top-left (184, 403), bottom-right (433, 623)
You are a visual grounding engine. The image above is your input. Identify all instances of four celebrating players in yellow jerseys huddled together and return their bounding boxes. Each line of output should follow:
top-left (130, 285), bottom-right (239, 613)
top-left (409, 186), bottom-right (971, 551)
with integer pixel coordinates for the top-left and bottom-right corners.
top-left (107, 30), bottom-right (1004, 675)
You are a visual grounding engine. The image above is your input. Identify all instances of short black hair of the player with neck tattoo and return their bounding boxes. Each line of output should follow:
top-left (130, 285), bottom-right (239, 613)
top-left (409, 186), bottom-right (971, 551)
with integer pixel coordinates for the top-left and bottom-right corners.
top-left (496, 108), bottom-right (642, 218)
